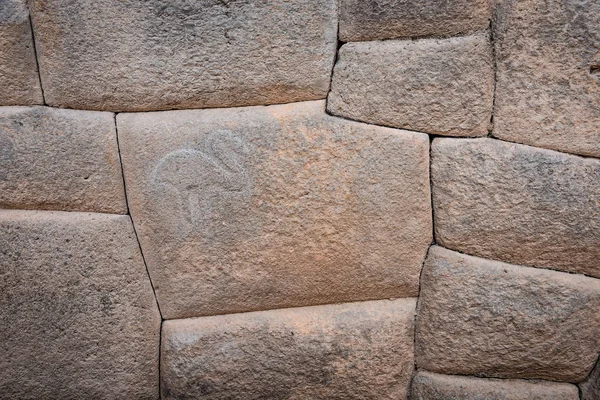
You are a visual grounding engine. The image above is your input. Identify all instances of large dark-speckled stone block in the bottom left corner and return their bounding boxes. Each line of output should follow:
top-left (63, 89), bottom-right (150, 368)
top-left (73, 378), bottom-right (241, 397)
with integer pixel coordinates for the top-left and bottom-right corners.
top-left (0, 210), bottom-right (160, 399)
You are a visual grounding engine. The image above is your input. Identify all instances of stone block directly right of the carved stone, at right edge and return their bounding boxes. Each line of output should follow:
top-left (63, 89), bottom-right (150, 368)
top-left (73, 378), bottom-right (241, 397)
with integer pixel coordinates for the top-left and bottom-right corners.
top-left (432, 138), bottom-right (600, 277)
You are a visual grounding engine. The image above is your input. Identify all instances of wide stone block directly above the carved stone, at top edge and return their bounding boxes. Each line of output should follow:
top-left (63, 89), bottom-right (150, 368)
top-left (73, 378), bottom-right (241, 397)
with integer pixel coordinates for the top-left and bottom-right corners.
top-left (31, 0), bottom-right (337, 111)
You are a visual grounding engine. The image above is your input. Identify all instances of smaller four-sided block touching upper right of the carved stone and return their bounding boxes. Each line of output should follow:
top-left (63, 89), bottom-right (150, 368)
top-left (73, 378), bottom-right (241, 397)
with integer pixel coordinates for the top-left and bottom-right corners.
top-left (328, 33), bottom-right (494, 136)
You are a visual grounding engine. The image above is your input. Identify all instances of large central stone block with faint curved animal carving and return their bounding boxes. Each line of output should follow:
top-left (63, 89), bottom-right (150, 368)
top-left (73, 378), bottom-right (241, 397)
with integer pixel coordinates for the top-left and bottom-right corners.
top-left (117, 101), bottom-right (431, 319)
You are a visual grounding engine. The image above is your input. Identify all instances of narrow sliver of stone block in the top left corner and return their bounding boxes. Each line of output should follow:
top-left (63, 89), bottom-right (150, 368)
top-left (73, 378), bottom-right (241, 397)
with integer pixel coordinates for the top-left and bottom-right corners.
top-left (0, 0), bottom-right (43, 106)
